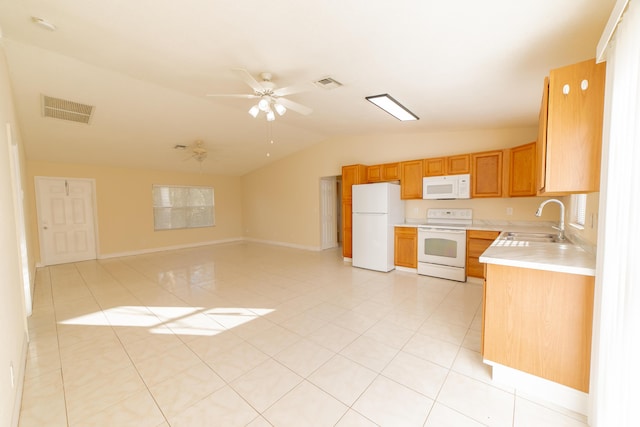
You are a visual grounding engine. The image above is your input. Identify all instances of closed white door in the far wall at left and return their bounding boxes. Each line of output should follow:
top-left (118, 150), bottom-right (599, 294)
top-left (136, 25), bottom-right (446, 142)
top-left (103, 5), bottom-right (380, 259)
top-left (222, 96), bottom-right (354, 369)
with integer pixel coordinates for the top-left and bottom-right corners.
top-left (36, 177), bottom-right (96, 265)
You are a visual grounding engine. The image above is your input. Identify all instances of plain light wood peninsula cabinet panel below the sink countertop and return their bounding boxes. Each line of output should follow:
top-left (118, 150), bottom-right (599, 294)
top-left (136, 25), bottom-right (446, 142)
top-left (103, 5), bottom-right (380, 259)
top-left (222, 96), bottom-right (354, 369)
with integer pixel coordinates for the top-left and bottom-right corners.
top-left (482, 264), bottom-right (594, 393)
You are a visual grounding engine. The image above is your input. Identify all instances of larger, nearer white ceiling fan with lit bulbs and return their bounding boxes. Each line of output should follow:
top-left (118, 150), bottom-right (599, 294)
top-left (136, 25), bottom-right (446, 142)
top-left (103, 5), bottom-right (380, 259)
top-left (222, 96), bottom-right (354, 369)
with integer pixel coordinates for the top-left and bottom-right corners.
top-left (207, 68), bottom-right (313, 122)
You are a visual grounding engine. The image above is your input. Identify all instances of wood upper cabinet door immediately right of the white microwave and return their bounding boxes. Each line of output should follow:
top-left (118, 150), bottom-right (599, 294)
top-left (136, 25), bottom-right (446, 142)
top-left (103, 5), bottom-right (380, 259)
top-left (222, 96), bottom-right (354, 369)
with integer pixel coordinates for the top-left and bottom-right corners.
top-left (471, 150), bottom-right (503, 197)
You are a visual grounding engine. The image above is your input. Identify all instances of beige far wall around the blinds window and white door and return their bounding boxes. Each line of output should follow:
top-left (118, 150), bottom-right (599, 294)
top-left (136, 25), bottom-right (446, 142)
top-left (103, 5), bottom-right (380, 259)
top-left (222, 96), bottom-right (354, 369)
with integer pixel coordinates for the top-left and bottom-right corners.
top-left (27, 161), bottom-right (242, 258)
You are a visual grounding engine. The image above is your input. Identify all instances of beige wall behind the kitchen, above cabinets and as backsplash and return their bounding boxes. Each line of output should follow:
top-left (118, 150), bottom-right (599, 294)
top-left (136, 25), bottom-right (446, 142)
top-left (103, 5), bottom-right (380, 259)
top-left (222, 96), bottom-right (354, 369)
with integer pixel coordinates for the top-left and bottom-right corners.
top-left (243, 127), bottom-right (584, 249)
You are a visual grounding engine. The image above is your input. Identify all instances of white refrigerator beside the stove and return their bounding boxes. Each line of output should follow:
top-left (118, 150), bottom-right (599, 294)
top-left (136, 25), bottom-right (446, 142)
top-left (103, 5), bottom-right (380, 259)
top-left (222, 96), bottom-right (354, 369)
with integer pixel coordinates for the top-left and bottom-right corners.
top-left (351, 182), bottom-right (404, 272)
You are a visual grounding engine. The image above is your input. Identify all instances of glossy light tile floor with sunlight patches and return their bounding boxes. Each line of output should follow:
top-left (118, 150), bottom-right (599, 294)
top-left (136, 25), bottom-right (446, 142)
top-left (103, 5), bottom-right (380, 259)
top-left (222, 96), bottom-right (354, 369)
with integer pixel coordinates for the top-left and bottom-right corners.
top-left (20, 243), bottom-right (586, 427)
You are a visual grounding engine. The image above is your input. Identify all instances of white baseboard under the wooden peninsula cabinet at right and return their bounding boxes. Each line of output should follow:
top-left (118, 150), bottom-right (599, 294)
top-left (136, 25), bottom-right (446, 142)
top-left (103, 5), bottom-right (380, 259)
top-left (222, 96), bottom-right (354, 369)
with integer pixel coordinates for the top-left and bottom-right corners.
top-left (483, 359), bottom-right (589, 415)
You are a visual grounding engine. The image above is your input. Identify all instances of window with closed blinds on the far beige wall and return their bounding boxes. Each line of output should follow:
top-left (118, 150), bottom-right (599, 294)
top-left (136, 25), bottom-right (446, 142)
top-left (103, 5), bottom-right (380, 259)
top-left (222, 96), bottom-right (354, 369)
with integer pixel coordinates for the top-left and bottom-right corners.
top-left (153, 185), bottom-right (215, 230)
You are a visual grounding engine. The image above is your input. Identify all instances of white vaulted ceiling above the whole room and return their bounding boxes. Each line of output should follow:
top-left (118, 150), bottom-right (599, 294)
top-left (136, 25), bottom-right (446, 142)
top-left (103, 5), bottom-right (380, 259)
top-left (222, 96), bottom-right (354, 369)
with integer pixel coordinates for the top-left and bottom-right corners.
top-left (0, 0), bottom-right (615, 175)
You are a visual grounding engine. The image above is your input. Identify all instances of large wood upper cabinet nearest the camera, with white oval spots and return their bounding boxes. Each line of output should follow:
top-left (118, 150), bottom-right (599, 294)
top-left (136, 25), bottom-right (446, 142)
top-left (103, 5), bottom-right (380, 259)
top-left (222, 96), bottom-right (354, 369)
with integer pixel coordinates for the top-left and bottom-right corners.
top-left (537, 59), bottom-right (606, 195)
